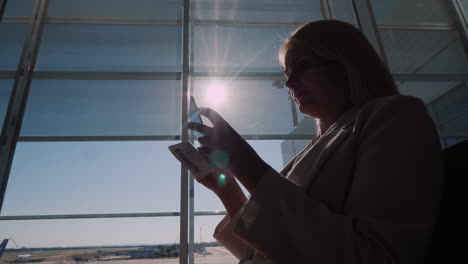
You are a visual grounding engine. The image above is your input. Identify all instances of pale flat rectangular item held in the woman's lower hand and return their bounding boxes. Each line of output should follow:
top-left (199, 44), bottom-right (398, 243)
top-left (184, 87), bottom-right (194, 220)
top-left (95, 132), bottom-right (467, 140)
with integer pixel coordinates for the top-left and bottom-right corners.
top-left (169, 142), bottom-right (211, 178)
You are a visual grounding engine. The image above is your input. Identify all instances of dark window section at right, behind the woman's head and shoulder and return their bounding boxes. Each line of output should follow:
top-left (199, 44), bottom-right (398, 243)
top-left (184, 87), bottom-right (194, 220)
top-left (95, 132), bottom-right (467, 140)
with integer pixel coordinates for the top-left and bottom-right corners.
top-left (372, 0), bottom-right (468, 147)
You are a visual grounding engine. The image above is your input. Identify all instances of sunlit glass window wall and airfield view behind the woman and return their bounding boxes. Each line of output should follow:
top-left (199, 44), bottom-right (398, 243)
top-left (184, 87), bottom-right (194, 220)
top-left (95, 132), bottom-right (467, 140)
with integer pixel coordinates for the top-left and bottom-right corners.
top-left (0, 0), bottom-right (468, 264)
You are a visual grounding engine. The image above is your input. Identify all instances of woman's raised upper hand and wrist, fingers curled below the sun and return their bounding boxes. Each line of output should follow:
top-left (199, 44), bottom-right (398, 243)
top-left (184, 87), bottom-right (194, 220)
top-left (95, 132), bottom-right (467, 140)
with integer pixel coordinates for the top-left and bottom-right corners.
top-left (187, 107), bottom-right (268, 192)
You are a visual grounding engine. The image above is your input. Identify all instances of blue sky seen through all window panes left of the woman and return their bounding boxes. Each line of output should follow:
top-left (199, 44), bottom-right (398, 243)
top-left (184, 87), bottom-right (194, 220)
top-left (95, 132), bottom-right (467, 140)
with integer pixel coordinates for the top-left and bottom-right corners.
top-left (0, 0), bottom-right (322, 251)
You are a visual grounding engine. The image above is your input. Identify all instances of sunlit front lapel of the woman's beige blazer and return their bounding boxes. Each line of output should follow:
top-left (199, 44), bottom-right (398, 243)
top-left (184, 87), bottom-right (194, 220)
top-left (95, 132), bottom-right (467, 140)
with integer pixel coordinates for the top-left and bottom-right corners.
top-left (281, 107), bottom-right (358, 188)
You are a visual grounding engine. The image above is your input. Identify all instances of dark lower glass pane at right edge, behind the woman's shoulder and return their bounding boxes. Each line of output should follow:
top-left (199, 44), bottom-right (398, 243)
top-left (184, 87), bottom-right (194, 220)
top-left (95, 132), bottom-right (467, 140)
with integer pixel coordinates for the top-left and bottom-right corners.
top-left (428, 82), bottom-right (468, 138)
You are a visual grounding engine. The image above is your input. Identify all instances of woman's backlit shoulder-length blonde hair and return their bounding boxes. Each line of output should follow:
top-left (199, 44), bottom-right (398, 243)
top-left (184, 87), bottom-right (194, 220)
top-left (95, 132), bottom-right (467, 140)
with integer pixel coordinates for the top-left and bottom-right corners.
top-left (278, 20), bottom-right (399, 108)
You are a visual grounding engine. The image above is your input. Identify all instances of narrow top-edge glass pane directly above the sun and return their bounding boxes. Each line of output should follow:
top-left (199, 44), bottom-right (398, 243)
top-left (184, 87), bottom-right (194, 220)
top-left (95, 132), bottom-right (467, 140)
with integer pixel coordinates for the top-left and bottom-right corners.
top-left (191, 0), bottom-right (322, 22)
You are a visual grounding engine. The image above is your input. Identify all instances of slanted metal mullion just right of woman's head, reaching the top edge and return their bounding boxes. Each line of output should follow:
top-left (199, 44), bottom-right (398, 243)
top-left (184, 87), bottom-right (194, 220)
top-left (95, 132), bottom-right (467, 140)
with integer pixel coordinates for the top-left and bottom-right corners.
top-left (353, 0), bottom-right (388, 66)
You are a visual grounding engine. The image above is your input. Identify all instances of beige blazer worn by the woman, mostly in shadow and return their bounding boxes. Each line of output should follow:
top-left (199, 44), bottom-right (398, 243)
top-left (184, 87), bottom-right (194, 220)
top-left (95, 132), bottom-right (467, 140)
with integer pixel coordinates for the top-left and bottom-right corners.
top-left (214, 95), bottom-right (443, 264)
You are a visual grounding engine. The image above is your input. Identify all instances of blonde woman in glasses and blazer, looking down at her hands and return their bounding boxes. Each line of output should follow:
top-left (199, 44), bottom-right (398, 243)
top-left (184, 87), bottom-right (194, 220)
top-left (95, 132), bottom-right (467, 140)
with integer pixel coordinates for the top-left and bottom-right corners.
top-left (188, 20), bottom-right (443, 264)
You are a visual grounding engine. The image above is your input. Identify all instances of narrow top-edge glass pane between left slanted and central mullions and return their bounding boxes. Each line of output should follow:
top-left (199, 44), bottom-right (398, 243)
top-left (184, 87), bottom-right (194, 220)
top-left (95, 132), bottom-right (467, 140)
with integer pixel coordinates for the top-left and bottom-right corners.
top-left (48, 0), bottom-right (183, 20)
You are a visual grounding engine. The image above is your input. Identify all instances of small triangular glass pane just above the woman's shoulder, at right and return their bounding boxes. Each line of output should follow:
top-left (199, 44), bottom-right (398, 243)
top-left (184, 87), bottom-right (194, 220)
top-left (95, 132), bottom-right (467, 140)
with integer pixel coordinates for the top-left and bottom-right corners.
top-left (398, 81), bottom-right (458, 104)
